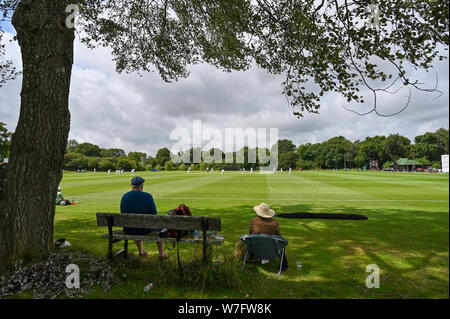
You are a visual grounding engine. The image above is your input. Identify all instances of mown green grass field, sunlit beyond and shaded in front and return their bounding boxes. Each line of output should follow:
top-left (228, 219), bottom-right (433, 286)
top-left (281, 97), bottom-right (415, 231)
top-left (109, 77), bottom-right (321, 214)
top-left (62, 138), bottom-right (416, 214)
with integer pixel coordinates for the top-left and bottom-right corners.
top-left (51, 171), bottom-right (449, 298)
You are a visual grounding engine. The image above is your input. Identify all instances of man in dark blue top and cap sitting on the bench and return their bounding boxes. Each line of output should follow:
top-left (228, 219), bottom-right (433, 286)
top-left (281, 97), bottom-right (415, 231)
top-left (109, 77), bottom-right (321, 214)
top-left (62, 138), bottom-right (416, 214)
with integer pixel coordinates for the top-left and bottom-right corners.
top-left (120, 176), bottom-right (169, 259)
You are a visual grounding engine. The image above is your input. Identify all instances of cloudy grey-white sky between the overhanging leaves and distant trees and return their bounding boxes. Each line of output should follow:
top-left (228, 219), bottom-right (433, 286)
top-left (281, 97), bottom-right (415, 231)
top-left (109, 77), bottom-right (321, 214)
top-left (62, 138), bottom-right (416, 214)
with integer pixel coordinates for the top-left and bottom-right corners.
top-left (0, 29), bottom-right (449, 155)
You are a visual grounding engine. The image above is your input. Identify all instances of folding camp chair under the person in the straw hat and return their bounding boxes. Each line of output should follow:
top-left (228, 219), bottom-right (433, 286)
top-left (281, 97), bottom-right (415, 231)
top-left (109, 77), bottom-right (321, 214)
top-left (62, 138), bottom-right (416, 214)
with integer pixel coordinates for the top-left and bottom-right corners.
top-left (241, 234), bottom-right (288, 276)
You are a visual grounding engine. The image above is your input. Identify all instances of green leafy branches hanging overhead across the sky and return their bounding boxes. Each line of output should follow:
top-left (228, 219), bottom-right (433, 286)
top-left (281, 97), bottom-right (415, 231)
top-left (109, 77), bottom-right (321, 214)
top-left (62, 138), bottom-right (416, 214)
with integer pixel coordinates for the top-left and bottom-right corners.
top-left (0, 0), bottom-right (449, 116)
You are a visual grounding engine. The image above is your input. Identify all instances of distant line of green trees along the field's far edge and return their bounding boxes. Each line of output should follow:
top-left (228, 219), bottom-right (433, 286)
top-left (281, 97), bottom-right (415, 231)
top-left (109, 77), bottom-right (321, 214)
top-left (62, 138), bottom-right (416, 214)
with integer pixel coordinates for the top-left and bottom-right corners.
top-left (29, 128), bottom-right (449, 171)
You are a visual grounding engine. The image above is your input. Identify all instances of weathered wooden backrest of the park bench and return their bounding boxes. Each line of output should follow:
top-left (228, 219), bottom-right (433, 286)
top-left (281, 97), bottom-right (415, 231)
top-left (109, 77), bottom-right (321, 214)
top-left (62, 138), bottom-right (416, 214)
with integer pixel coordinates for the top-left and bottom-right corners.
top-left (97, 213), bottom-right (222, 231)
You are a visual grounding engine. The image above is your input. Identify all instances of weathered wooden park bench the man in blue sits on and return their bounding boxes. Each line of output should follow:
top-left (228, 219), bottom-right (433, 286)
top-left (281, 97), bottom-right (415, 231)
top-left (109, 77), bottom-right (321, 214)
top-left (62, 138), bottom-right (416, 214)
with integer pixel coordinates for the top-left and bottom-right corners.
top-left (97, 213), bottom-right (225, 262)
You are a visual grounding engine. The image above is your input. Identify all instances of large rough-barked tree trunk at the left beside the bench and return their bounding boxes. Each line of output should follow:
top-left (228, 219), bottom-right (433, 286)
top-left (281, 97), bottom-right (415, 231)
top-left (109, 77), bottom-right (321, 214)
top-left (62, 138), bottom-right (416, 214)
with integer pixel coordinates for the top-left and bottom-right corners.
top-left (0, 0), bottom-right (76, 260)
